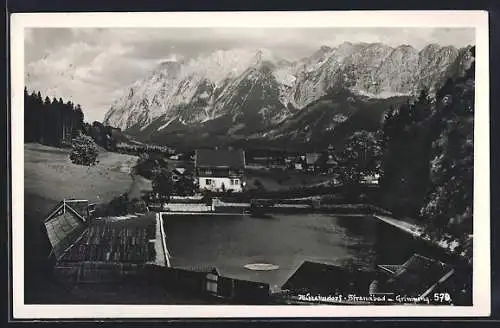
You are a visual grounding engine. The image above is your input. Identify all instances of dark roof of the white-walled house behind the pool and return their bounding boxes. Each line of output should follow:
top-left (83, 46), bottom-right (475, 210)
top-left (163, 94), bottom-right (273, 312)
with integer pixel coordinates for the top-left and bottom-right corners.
top-left (195, 149), bottom-right (245, 169)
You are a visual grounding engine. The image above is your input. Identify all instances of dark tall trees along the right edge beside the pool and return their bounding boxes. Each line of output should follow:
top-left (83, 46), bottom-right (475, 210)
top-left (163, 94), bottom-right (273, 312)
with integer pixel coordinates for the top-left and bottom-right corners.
top-left (381, 48), bottom-right (475, 255)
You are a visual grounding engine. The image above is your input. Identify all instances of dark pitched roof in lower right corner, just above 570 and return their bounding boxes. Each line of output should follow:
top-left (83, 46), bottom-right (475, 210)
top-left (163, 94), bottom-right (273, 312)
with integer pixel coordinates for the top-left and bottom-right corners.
top-left (385, 254), bottom-right (453, 296)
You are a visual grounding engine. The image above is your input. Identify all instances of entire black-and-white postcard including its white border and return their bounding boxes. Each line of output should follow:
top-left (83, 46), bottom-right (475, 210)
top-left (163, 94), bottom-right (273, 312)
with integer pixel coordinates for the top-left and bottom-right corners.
top-left (11, 12), bottom-right (490, 318)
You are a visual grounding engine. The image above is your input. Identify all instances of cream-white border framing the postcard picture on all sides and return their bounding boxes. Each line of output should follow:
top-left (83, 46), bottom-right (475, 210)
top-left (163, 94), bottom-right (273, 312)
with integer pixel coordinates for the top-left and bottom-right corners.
top-left (10, 11), bottom-right (491, 319)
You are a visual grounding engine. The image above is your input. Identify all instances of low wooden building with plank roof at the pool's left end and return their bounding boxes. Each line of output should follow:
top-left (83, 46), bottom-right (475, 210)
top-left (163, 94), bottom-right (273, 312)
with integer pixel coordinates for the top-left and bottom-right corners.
top-left (45, 201), bottom-right (170, 283)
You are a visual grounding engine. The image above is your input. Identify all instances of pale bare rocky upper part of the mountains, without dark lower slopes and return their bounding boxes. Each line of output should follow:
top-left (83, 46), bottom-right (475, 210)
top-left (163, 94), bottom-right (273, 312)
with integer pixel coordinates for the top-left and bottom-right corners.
top-left (105, 42), bottom-right (468, 146)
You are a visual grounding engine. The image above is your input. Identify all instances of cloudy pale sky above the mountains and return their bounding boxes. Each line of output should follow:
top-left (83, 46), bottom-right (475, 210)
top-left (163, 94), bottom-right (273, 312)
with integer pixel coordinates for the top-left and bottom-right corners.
top-left (25, 28), bottom-right (474, 122)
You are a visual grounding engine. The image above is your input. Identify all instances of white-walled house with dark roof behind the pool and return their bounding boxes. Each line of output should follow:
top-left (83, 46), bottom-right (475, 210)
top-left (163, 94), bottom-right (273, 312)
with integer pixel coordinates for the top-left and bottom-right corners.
top-left (194, 149), bottom-right (245, 192)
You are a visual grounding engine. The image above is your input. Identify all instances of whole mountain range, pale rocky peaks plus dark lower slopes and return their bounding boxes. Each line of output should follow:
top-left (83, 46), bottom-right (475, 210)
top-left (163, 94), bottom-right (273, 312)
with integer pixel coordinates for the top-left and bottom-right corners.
top-left (104, 42), bottom-right (471, 148)
